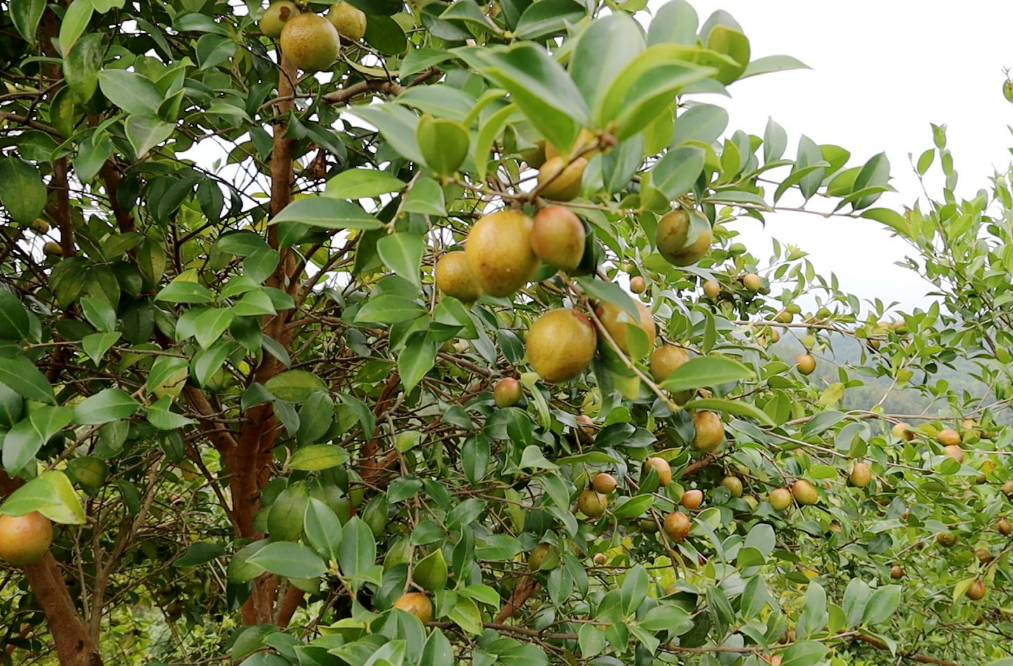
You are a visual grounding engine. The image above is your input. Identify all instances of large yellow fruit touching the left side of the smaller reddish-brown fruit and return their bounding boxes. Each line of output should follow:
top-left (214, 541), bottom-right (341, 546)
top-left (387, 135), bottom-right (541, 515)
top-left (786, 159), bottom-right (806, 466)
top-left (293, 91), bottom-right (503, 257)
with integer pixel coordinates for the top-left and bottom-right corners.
top-left (464, 211), bottom-right (538, 297)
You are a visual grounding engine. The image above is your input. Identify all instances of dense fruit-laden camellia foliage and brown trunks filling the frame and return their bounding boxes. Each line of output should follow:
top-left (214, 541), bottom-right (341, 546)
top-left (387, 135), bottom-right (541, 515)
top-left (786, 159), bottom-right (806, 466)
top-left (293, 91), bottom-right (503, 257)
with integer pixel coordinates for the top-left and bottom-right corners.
top-left (0, 0), bottom-right (1013, 666)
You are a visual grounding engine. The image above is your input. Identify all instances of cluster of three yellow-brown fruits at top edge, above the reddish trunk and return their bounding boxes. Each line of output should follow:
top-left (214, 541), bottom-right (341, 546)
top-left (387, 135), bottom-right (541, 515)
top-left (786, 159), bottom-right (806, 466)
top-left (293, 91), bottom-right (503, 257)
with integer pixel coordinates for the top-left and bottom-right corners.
top-left (258, 0), bottom-right (367, 72)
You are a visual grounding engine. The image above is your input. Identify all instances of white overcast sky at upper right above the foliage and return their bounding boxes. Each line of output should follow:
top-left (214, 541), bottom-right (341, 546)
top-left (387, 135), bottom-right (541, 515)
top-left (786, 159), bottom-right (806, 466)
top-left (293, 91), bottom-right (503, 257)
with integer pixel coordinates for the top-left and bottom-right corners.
top-left (649, 0), bottom-right (1013, 309)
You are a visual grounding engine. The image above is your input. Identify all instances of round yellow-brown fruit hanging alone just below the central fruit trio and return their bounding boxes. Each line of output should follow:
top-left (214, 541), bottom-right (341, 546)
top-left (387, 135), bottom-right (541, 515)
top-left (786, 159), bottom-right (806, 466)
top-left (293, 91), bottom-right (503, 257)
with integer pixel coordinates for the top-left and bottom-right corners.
top-left (527, 308), bottom-right (598, 383)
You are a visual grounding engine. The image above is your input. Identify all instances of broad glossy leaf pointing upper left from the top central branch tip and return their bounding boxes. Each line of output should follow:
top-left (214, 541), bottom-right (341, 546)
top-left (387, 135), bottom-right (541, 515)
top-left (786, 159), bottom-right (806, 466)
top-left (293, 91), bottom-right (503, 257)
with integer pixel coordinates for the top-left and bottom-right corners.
top-left (454, 43), bottom-right (590, 153)
